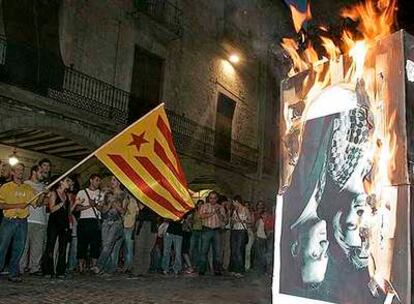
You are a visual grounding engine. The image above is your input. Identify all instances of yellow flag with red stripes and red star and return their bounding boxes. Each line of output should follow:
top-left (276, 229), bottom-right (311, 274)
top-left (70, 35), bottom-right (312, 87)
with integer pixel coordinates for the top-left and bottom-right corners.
top-left (95, 104), bottom-right (194, 220)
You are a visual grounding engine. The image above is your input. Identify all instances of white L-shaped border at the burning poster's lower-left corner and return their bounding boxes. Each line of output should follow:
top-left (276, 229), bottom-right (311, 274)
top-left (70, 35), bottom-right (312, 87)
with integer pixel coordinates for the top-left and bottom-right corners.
top-left (272, 195), bottom-right (335, 304)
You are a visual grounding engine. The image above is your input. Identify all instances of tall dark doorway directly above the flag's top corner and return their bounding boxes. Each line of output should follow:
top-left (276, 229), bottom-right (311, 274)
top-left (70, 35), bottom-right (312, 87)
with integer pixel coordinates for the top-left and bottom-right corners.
top-left (128, 46), bottom-right (164, 123)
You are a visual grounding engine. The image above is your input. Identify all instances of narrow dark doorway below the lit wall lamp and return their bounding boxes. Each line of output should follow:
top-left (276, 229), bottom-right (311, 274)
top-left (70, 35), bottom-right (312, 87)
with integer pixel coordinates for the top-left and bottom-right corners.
top-left (214, 93), bottom-right (236, 161)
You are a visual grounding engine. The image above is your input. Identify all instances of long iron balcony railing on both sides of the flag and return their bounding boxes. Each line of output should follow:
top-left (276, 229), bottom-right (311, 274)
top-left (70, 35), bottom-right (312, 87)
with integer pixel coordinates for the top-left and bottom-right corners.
top-left (0, 40), bottom-right (258, 173)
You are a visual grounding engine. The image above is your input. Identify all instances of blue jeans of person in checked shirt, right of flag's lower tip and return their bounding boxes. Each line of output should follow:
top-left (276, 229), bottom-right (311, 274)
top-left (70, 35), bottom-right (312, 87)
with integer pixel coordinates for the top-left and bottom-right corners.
top-left (199, 228), bottom-right (221, 273)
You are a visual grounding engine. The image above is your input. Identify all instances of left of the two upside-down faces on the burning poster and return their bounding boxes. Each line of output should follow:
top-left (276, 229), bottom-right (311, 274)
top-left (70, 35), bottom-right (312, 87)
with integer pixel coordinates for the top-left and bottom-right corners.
top-left (298, 219), bottom-right (329, 284)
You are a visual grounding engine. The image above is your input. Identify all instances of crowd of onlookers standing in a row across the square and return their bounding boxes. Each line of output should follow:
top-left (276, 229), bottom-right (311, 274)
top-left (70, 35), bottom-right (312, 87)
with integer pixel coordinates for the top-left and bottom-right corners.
top-left (0, 159), bottom-right (274, 282)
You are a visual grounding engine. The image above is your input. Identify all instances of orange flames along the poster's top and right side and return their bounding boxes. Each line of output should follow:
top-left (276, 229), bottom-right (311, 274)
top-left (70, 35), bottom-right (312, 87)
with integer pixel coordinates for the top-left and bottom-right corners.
top-left (282, 0), bottom-right (397, 291)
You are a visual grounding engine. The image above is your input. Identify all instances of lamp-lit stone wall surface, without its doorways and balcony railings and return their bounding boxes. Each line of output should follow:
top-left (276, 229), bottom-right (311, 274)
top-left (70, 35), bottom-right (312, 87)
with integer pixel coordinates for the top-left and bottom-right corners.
top-left (0, 0), bottom-right (350, 204)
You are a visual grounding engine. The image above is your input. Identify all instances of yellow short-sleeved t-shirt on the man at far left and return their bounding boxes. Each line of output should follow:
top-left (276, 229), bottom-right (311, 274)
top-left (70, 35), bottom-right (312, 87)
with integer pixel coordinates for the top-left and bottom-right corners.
top-left (0, 182), bottom-right (36, 219)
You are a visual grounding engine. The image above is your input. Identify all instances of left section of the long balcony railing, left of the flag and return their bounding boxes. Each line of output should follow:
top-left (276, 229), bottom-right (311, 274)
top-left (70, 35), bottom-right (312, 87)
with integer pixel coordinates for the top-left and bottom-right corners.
top-left (0, 39), bottom-right (130, 124)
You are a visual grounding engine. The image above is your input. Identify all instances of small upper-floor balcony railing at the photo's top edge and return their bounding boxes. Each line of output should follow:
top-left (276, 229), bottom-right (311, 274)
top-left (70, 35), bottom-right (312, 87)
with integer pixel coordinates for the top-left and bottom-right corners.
top-left (132, 0), bottom-right (183, 37)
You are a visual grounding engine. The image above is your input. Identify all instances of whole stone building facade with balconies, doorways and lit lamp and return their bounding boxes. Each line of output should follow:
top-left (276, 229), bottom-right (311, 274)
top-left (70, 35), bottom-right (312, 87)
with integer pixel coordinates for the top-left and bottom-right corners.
top-left (0, 0), bottom-right (291, 202)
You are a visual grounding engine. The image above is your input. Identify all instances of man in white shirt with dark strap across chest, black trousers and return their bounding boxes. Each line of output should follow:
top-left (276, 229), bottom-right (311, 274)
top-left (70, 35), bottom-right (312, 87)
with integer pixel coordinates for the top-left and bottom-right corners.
top-left (74, 174), bottom-right (104, 272)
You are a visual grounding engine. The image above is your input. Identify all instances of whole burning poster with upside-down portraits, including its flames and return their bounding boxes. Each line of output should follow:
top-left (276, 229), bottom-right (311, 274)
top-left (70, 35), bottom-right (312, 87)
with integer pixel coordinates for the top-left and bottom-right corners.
top-left (274, 1), bottom-right (413, 304)
